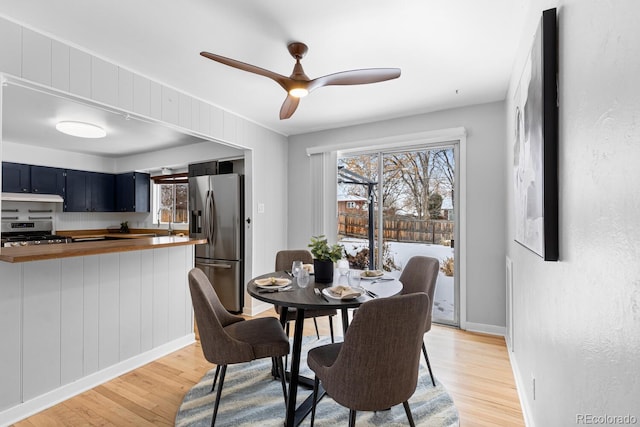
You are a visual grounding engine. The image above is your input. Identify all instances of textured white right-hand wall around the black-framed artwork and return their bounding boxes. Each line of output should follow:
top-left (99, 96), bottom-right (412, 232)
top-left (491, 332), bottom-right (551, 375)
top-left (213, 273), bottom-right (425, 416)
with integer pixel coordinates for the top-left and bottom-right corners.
top-left (505, 0), bottom-right (640, 427)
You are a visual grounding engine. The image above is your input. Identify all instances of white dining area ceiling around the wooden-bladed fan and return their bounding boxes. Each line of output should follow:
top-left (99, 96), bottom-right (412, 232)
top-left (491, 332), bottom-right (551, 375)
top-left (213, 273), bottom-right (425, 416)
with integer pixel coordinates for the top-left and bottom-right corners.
top-left (0, 0), bottom-right (529, 152)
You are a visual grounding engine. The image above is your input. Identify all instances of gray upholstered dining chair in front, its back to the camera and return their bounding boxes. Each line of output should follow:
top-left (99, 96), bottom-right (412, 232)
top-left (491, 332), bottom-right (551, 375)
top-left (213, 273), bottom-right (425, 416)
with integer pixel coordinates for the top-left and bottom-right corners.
top-left (307, 293), bottom-right (430, 426)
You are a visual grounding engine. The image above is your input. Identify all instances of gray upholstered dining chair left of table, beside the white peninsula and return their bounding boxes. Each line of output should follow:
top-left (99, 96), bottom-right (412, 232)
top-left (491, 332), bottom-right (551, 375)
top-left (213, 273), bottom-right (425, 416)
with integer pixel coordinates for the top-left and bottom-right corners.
top-left (189, 268), bottom-right (289, 426)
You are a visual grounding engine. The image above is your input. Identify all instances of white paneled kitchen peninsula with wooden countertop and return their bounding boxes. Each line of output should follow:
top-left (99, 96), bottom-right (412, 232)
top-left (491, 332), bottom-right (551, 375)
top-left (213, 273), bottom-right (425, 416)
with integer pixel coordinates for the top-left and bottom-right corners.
top-left (0, 237), bottom-right (202, 425)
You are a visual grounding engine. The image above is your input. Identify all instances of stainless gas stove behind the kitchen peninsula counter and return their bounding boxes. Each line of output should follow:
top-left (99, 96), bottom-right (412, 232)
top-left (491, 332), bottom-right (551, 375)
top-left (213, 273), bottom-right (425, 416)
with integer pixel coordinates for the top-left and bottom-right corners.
top-left (0, 221), bottom-right (71, 248)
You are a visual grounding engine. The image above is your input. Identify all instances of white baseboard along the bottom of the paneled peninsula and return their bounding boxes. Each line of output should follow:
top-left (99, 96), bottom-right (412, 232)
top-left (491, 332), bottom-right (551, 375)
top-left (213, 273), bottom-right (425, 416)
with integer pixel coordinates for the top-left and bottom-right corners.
top-left (0, 333), bottom-right (195, 426)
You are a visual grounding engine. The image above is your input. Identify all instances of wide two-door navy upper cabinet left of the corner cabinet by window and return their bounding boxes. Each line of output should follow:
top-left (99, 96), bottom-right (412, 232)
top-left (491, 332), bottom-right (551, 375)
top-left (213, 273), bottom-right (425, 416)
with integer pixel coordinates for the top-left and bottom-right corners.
top-left (64, 169), bottom-right (115, 212)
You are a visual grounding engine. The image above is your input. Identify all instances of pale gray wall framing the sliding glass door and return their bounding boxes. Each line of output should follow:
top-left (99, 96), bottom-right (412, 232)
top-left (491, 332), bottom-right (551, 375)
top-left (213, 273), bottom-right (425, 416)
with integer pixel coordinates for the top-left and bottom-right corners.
top-left (287, 102), bottom-right (506, 329)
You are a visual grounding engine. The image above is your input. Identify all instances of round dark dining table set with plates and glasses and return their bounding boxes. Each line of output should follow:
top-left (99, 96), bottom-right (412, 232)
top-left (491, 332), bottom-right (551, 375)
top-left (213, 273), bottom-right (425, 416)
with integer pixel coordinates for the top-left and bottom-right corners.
top-left (247, 270), bottom-right (402, 427)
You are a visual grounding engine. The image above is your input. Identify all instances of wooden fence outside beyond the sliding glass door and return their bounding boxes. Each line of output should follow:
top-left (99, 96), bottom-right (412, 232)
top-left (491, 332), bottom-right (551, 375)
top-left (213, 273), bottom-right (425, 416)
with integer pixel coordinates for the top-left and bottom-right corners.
top-left (338, 213), bottom-right (454, 245)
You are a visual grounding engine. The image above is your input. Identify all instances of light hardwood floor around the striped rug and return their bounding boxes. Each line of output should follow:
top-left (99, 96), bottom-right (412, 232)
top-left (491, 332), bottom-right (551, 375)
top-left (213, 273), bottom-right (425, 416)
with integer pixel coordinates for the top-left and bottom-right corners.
top-left (15, 311), bottom-right (524, 427)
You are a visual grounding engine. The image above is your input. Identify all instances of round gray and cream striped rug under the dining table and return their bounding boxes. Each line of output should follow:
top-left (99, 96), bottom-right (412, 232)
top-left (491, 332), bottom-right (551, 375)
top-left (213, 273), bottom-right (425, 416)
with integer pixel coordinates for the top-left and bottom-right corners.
top-left (175, 337), bottom-right (459, 427)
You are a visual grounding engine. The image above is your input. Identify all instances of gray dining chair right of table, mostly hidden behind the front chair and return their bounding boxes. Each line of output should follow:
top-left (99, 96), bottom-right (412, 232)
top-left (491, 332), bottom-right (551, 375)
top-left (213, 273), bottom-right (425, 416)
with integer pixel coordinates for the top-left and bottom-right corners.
top-left (399, 256), bottom-right (440, 387)
